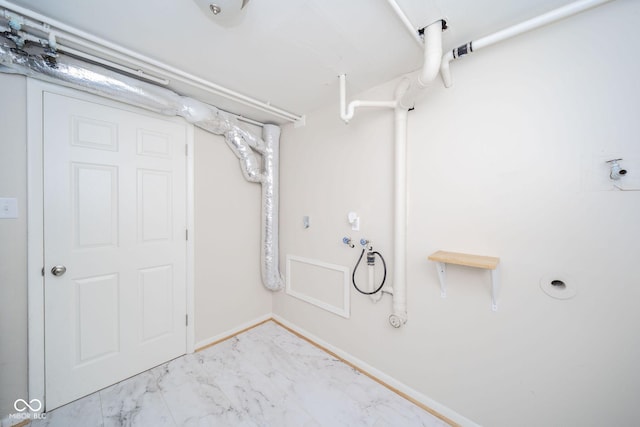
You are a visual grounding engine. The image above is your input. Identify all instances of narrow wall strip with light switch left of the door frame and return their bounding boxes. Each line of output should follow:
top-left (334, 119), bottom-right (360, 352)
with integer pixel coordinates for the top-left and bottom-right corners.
top-left (0, 74), bottom-right (28, 420)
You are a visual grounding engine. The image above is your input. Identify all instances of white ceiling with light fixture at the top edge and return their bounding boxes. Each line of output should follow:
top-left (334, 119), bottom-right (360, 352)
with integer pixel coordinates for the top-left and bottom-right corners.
top-left (7, 0), bottom-right (571, 123)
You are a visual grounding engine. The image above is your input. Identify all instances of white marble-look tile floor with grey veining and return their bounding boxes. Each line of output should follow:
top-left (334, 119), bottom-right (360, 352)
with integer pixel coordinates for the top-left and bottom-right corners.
top-left (31, 322), bottom-right (447, 427)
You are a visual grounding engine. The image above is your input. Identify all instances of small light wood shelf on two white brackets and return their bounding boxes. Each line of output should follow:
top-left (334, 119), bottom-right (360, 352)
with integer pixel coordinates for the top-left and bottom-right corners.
top-left (428, 251), bottom-right (500, 311)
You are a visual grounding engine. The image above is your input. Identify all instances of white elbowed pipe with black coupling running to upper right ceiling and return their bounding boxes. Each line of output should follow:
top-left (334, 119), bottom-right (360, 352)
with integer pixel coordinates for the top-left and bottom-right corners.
top-left (440, 0), bottom-right (612, 87)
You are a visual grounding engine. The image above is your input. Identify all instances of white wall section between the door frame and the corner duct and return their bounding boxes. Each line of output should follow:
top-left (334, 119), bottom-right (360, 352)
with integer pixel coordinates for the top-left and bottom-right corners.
top-left (195, 128), bottom-right (271, 347)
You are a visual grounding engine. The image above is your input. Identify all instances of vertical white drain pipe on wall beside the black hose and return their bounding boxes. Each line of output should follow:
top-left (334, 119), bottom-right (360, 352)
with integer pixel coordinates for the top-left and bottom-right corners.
top-left (389, 108), bottom-right (408, 328)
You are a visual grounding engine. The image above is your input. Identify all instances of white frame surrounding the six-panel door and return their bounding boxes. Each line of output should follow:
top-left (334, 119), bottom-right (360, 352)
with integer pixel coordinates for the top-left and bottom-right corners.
top-left (27, 78), bottom-right (195, 409)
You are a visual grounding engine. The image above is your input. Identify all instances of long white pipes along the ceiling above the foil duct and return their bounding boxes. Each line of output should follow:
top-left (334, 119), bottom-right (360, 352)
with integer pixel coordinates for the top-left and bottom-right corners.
top-left (0, 0), bottom-right (302, 122)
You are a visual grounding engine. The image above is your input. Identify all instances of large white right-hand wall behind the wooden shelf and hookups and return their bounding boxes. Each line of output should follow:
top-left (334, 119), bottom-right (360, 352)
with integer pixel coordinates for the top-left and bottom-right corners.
top-left (274, 0), bottom-right (640, 426)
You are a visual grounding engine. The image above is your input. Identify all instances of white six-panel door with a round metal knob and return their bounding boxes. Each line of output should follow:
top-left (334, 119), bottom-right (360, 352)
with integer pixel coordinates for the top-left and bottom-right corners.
top-left (43, 92), bottom-right (187, 410)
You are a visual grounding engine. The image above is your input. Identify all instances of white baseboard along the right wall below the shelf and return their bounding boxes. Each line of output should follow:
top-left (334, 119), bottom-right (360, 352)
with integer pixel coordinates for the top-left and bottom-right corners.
top-left (271, 314), bottom-right (480, 427)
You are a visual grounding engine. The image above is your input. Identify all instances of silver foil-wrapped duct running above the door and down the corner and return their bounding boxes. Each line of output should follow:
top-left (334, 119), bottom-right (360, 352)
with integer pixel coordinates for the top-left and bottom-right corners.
top-left (0, 35), bottom-right (283, 291)
